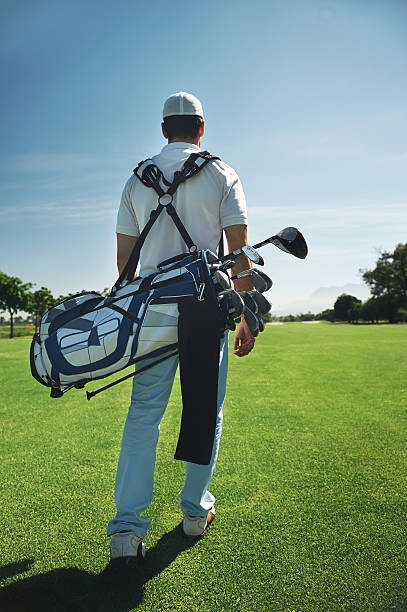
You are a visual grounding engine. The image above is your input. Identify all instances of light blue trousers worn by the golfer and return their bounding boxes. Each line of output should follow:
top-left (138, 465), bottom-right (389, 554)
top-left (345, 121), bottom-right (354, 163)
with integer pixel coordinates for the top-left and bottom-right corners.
top-left (107, 333), bottom-right (228, 538)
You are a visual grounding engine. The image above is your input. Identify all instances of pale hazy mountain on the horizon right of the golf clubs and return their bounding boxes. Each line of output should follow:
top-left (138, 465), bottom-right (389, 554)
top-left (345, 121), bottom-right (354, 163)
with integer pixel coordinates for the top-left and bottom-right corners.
top-left (272, 283), bottom-right (370, 315)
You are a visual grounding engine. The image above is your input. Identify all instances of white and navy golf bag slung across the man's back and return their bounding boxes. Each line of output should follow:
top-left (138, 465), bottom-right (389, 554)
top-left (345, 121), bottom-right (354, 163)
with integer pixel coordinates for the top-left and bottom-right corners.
top-left (31, 251), bottom-right (225, 397)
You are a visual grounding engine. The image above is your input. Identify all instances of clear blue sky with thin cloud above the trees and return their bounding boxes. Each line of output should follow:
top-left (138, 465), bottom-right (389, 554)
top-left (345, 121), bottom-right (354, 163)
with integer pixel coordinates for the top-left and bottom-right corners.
top-left (0, 0), bottom-right (407, 312)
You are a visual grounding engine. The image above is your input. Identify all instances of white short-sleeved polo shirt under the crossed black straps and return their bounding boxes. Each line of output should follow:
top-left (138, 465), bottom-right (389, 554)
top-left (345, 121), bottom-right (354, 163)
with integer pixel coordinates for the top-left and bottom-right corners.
top-left (116, 142), bottom-right (247, 276)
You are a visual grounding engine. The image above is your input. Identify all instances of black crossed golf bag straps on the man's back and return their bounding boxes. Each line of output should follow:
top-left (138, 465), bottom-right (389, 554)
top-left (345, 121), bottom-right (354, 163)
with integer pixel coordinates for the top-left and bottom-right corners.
top-left (112, 151), bottom-right (220, 293)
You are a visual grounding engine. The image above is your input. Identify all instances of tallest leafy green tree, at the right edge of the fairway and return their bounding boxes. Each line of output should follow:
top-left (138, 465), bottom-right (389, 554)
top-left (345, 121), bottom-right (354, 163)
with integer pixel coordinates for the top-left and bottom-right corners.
top-left (360, 243), bottom-right (407, 323)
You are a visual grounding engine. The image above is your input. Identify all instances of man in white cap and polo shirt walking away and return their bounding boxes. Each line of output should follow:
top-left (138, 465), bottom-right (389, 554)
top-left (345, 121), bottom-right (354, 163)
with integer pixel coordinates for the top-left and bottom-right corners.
top-left (107, 92), bottom-right (254, 567)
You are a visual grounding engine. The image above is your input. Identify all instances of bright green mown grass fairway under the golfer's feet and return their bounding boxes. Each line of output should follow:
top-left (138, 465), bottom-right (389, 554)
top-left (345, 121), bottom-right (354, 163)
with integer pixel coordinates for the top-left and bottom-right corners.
top-left (0, 323), bottom-right (407, 612)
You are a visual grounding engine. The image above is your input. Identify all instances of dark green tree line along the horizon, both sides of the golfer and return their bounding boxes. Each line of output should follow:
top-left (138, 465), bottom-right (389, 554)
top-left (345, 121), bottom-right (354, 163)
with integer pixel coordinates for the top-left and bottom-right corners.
top-left (0, 243), bottom-right (407, 338)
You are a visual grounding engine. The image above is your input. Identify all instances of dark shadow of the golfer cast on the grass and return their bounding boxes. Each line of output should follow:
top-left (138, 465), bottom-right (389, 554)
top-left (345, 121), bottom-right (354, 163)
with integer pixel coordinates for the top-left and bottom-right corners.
top-left (0, 525), bottom-right (195, 612)
